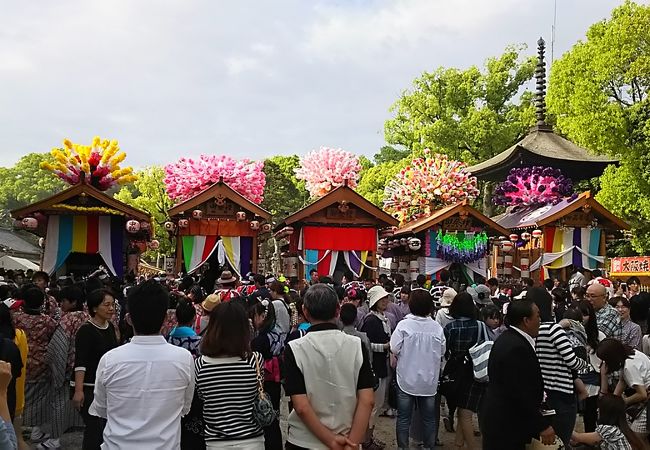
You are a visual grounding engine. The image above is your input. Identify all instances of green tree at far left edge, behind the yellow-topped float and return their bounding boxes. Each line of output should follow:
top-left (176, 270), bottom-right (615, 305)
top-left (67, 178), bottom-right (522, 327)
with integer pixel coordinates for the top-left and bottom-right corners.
top-left (0, 153), bottom-right (67, 224)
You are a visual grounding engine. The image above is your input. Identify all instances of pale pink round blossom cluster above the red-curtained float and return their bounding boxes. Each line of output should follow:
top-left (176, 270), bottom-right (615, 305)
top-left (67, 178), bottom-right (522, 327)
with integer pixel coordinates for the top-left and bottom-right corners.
top-left (295, 147), bottom-right (361, 197)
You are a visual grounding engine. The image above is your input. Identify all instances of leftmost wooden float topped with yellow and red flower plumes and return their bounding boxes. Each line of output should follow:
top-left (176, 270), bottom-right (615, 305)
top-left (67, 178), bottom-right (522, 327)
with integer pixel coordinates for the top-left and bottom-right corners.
top-left (11, 137), bottom-right (152, 278)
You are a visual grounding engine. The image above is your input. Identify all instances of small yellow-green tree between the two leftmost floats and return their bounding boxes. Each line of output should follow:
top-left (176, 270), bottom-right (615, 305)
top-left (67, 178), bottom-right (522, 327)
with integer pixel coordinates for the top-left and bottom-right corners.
top-left (114, 166), bottom-right (175, 255)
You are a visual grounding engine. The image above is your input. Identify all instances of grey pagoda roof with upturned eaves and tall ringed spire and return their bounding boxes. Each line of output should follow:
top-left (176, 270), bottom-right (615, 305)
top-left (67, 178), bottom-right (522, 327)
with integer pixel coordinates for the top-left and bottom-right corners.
top-left (468, 38), bottom-right (618, 181)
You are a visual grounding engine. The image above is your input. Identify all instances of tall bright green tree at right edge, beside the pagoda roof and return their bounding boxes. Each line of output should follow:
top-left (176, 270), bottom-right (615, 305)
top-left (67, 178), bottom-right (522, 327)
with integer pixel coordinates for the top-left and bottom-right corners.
top-left (547, 1), bottom-right (650, 254)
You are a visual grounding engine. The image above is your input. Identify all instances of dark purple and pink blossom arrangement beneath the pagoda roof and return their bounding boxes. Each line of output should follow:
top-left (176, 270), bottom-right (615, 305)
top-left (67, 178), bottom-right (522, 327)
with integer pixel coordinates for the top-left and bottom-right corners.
top-left (492, 166), bottom-right (574, 207)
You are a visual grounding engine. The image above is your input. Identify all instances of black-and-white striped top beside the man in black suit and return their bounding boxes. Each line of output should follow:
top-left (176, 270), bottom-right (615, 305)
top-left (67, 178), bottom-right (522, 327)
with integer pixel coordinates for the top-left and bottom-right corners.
top-left (535, 322), bottom-right (587, 394)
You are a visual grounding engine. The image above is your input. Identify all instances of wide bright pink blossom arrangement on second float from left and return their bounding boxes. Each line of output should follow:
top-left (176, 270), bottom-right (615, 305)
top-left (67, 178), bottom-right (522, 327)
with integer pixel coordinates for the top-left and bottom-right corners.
top-left (165, 155), bottom-right (266, 203)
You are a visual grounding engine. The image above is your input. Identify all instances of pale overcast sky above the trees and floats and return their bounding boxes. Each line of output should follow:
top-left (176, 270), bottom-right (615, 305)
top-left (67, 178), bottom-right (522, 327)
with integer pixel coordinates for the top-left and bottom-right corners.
top-left (0, 0), bottom-right (636, 167)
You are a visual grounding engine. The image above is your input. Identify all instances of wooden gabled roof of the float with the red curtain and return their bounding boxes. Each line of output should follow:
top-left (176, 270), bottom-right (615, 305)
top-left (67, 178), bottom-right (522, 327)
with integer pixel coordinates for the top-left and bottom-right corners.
top-left (275, 183), bottom-right (399, 231)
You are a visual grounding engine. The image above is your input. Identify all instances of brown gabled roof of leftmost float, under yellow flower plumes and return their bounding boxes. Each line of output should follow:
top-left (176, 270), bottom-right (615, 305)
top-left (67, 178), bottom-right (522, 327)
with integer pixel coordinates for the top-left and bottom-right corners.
top-left (11, 183), bottom-right (151, 229)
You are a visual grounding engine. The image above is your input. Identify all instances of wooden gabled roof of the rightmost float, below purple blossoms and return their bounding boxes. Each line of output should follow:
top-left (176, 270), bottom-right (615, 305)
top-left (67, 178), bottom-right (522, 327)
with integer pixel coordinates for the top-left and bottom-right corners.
top-left (492, 191), bottom-right (630, 230)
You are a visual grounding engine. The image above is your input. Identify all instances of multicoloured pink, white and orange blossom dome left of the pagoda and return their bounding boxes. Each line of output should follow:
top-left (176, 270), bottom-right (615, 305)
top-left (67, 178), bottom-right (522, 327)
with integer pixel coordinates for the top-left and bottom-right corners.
top-left (384, 149), bottom-right (479, 224)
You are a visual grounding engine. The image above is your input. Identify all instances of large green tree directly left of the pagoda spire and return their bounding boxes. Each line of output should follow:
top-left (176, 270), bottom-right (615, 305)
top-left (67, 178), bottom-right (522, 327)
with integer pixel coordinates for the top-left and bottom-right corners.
top-left (384, 47), bottom-right (535, 164)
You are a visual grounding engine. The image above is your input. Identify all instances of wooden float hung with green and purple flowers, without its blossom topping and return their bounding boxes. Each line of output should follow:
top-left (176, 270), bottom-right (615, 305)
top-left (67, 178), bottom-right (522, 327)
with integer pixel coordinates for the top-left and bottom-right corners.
top-left (379, 200), bottom-right (507, 284)
